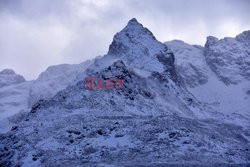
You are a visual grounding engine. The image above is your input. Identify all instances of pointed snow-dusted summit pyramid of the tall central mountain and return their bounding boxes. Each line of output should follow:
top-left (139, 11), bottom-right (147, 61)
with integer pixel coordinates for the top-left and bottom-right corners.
top-left (107, 19), bottom-right (174, 76)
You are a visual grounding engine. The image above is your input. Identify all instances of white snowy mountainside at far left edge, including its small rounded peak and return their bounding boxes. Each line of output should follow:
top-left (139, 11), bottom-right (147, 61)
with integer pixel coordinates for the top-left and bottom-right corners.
top-left (0, 69), bottom-right (30, 133)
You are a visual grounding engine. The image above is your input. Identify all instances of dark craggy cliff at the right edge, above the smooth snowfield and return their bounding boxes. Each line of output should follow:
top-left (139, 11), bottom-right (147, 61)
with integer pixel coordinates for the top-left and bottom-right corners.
top-left (205, 31), bottom-right (250, 85)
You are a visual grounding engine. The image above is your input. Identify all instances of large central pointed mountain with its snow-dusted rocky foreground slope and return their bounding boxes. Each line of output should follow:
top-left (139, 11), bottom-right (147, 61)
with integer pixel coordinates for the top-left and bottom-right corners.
top-left (0, 19), bottom-right (250, 166)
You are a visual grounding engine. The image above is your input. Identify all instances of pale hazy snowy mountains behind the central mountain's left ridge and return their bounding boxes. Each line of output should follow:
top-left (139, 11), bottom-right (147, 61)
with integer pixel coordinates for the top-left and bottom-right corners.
top-left (0, 60), bottom-right (93, 133)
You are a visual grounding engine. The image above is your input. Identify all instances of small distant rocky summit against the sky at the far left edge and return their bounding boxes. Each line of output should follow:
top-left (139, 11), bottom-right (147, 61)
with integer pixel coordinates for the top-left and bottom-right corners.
top-left (0, 69), bottom-right (25, 88)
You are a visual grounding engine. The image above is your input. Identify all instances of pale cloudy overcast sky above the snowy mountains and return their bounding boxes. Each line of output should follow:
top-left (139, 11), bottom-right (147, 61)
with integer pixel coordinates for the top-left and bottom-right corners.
top-left (0, 0), bottom-right (250, 80)
